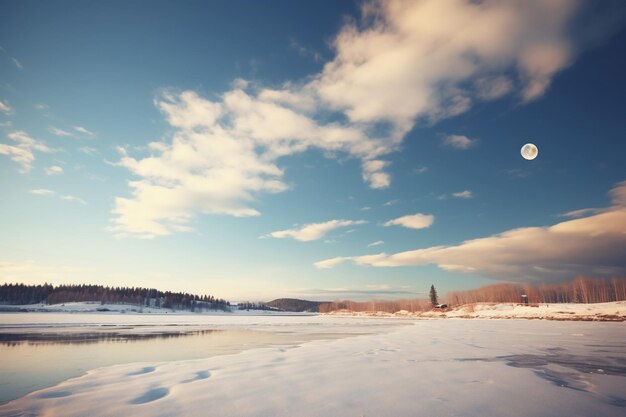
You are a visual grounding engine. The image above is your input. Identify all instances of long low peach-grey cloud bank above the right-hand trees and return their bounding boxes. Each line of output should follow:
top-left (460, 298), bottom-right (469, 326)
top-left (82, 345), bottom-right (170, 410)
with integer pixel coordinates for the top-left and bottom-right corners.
top-left (316, 181), bottom-right (626, 281)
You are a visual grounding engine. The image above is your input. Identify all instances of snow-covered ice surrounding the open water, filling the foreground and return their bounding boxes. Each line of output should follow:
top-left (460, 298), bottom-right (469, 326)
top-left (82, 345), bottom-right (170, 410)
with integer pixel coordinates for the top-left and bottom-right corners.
top-left (0, 313), bottom-right (626, 417)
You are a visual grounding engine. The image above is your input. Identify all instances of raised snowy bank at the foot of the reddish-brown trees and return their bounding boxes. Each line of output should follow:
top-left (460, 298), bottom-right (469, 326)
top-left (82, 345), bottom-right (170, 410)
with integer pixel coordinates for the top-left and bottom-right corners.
top-left (330, 301), bottom-right (626, 321)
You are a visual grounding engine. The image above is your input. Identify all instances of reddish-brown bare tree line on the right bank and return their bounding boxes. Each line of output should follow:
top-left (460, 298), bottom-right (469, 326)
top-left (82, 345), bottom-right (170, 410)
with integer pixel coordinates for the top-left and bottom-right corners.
top-left (447, 277), bottom-right (626, 305)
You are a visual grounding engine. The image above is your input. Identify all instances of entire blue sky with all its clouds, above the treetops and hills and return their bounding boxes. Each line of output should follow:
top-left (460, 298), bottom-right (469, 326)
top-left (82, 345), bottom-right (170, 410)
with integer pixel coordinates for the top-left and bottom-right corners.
top-left (0, 0), bottom-right (626, 301)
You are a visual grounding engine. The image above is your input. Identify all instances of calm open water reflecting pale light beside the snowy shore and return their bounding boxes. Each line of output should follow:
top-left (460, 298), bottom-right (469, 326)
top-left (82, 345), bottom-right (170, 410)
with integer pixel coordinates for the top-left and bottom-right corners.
top-left (0, 326), bottom-right (334, 403)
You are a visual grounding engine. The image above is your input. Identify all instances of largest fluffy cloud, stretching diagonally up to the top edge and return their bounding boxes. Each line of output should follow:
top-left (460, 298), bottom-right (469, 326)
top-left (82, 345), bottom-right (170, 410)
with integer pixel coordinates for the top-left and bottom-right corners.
top-left (111, 0), bottom-right (608, 237)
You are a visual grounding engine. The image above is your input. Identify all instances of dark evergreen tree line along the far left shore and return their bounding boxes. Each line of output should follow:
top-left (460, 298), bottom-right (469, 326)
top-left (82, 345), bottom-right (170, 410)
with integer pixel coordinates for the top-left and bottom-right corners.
top-left (0, 284), bottom-right (230, 311)
